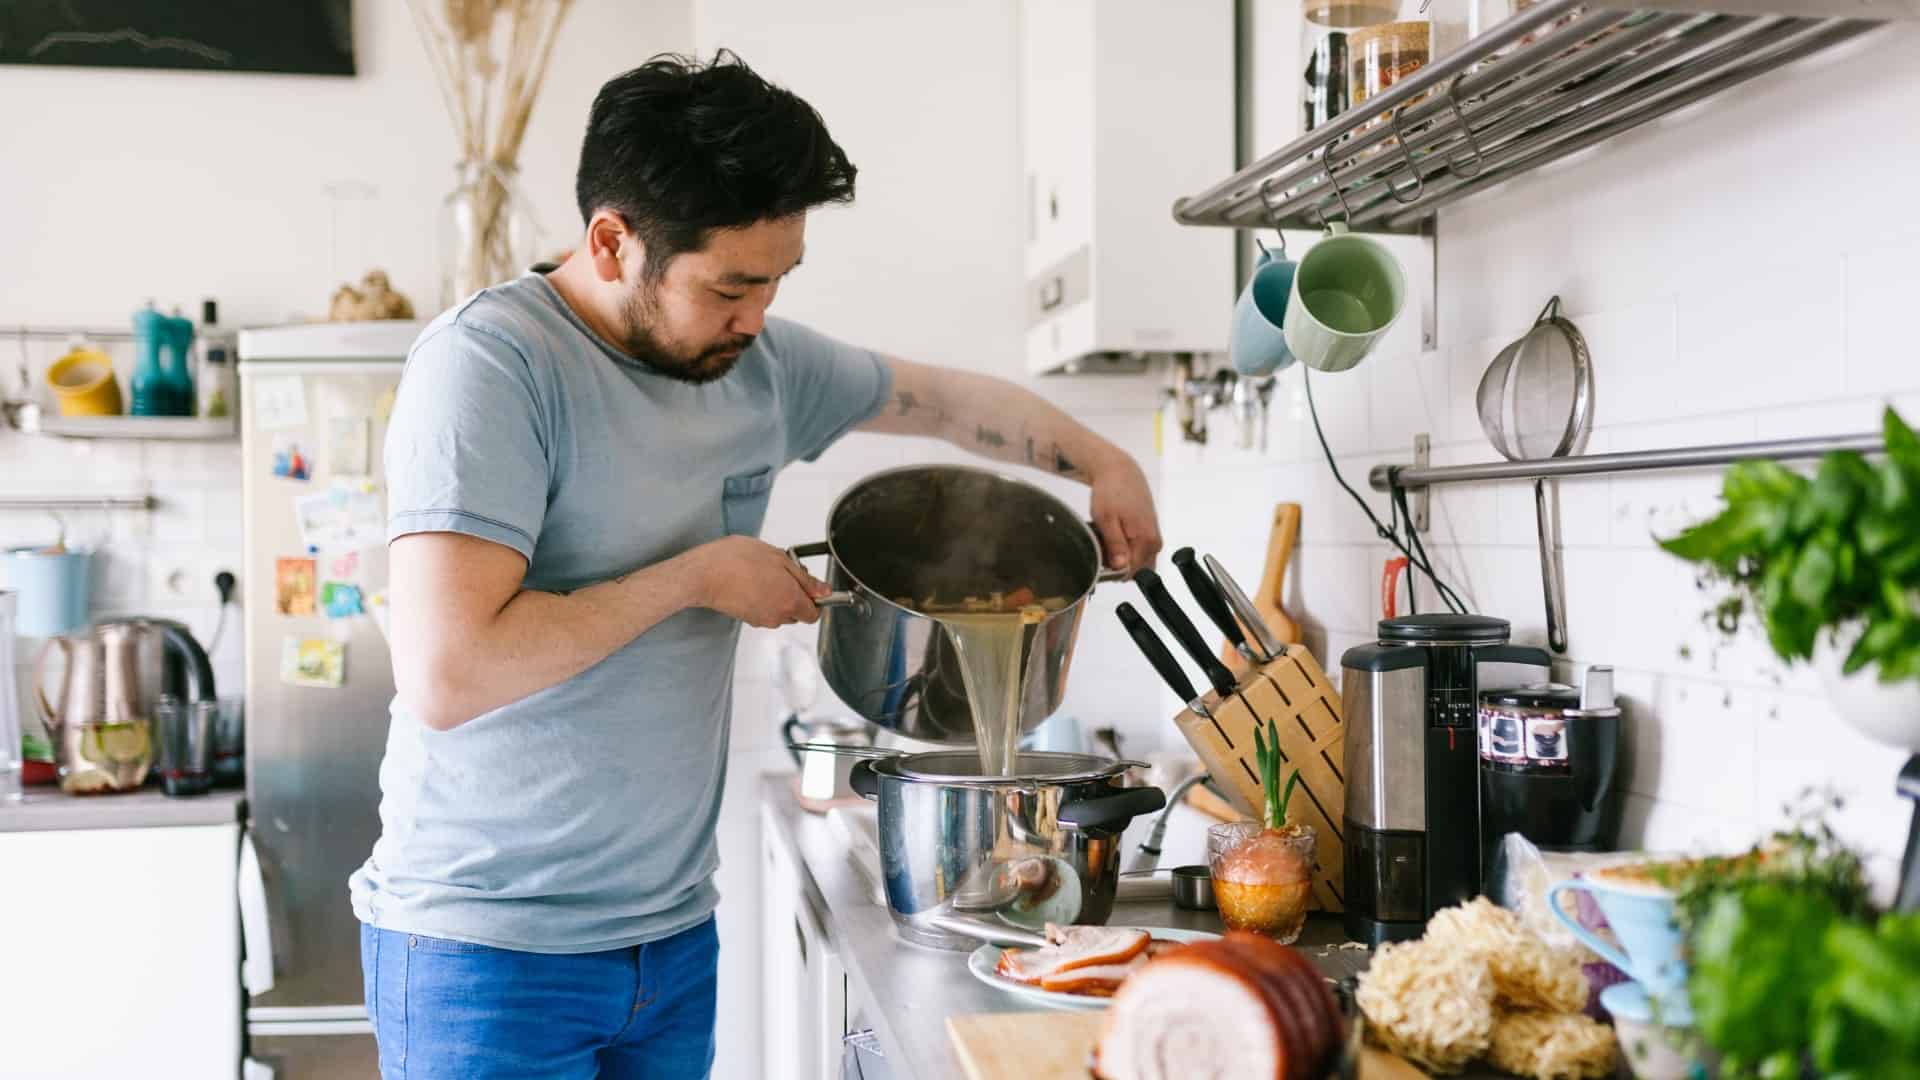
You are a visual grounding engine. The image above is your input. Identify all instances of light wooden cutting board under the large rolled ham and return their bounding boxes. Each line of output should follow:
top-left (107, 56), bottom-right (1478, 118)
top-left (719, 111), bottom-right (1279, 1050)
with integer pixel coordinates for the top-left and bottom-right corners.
top-left (947, 1011), bottom-right (1427, 1080)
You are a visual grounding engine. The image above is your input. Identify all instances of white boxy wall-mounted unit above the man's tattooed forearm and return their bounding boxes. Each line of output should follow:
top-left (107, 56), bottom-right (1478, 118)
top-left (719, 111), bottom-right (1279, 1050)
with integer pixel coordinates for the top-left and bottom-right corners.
top-left (1020, 0), bottom-right (1235, 373)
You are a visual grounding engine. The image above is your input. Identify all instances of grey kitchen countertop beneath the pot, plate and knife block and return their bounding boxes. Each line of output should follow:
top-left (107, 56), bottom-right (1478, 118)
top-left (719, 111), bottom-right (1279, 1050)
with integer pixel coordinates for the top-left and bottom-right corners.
top-left (760, 773), bottom-right (1367, 1080)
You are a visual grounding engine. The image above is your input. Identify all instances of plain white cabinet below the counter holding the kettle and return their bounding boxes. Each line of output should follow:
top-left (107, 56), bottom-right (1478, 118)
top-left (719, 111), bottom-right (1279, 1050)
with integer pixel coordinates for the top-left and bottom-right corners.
top-left (0, 818), bottom-right (240, 1080)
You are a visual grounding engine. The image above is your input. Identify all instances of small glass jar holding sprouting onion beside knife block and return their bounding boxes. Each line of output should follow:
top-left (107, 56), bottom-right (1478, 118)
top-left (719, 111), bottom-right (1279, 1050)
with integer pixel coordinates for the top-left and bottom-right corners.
top-left (1206, 821), bottom-right (1313, 945)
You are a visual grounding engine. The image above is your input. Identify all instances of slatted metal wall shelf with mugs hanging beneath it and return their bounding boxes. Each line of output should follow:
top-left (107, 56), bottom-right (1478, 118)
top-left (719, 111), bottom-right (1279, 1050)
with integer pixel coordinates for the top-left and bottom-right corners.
top-left (1173, 0), bottom-right (1920, 233)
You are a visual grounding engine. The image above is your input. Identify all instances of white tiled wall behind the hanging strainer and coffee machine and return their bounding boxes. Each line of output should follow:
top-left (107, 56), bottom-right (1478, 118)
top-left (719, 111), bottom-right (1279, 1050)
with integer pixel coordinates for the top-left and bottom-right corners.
top-left (1162, 4), bottom-right (1920, 887)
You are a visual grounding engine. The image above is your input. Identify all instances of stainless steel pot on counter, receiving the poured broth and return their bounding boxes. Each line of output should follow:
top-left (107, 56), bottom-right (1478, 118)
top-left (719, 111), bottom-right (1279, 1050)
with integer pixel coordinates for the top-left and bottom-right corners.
top-left (851, 749), bottom-right (1167, 949)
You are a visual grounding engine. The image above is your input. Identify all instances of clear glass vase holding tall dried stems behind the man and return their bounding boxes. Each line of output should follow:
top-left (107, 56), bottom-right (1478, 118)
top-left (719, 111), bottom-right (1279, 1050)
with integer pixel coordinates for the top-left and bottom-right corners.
top-left (438, 161), bottom-right (540, 307)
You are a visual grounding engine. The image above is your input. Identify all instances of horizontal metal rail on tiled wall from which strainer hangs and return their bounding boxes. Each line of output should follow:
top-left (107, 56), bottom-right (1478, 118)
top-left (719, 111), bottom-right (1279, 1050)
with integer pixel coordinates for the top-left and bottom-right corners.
top-left (1367, 432), bottom-right (1887, 492)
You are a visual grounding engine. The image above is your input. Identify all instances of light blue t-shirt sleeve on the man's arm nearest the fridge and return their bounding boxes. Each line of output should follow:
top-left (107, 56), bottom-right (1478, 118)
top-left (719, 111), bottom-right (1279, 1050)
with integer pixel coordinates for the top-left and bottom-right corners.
top-left (384, 323), bottom-right (551, 561)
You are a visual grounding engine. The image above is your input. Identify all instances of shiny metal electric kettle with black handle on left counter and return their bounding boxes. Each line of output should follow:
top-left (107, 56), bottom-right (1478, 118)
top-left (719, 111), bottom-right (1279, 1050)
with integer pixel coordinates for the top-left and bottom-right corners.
top-left (35, 619), bottom-right (215, 796)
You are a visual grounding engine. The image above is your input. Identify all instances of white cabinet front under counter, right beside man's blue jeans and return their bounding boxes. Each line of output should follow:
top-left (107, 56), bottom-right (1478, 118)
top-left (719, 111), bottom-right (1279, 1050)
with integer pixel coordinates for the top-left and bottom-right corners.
top-left (760, 807), bottom-right (847, 1080)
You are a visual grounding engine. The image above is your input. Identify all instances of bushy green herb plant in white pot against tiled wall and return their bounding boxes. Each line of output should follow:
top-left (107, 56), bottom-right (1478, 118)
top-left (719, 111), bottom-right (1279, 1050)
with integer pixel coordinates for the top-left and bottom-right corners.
top-left (1661, 407), bottom-right (1920, 751)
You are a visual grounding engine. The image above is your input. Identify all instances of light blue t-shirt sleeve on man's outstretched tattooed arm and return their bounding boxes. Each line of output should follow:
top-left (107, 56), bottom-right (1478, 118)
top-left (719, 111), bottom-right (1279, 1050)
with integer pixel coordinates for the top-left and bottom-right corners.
top-left (768, 313), bottom-right (893, 461)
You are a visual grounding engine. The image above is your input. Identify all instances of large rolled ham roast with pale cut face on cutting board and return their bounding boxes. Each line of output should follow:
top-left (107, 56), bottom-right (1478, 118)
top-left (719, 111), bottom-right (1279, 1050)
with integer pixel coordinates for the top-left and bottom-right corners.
top-left (1094, 934), bottom-right (1340, 1080)
